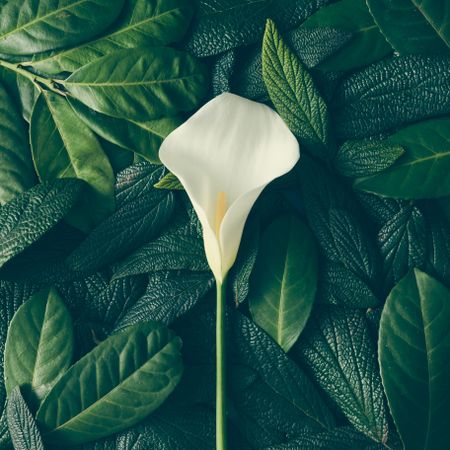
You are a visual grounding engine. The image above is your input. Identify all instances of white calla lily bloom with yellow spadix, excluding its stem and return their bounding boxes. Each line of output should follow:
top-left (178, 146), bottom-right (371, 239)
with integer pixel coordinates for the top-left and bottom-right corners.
top-left (159, 93), bottom-right (300, 282)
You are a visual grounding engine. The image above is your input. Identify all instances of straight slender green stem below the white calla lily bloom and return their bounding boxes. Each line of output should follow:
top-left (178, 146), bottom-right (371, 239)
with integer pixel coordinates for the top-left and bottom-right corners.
top-left (216, 279), bottom-right (227, 450)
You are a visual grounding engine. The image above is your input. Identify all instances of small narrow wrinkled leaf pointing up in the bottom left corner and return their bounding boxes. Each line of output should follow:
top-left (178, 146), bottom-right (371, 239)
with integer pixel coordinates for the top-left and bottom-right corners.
top-left (6, 386), bottom-right (44, 450)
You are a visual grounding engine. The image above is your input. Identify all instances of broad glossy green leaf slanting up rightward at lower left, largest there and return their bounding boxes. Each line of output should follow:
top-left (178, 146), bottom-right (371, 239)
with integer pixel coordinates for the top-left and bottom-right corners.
top-left (36, 322), bottom-right (183, 445)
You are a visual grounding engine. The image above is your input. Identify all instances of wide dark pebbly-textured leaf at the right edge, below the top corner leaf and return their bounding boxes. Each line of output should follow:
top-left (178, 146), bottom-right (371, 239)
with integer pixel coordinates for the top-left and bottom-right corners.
top-left (334, 55), bottom-right (450, 139)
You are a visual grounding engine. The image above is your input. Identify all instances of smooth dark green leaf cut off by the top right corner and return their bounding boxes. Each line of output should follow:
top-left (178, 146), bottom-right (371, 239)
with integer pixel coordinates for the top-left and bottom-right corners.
top-left (366, 0), bottom-right (450, 54)
